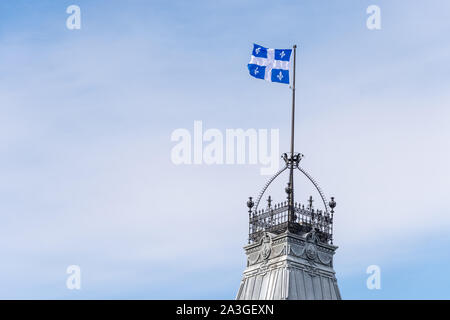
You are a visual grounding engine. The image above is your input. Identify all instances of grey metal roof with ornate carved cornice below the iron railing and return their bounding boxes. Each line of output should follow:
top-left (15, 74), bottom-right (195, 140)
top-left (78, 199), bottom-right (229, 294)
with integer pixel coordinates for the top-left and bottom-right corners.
top-left (236, 232), bottom-right (341, 300)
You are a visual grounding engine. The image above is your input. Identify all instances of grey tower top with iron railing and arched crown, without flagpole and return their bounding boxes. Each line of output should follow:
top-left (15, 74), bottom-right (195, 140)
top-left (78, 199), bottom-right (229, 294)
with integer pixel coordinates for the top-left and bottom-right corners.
top-left (236, 153), bottom-right (341, 300)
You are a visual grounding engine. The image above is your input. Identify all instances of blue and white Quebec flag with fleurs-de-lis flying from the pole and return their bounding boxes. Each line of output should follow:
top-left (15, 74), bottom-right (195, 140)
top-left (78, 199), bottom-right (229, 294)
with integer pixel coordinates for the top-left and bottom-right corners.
top-left (248, 44), bottom-right (292, 84)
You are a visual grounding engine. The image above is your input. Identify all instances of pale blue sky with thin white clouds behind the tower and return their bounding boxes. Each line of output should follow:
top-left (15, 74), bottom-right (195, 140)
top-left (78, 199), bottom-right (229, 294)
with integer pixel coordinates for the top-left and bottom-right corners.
top-left (0, 0), bottom-right (450, 299)
